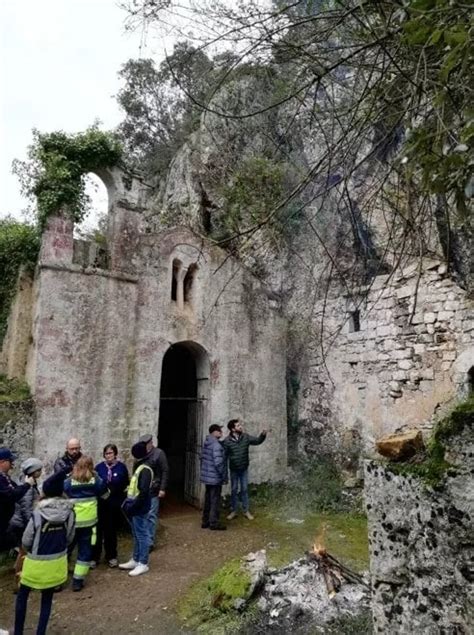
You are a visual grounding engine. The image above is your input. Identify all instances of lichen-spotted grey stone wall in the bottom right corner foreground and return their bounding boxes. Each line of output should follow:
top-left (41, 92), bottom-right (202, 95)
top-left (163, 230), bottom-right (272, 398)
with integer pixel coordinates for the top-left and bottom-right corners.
top-left (365, 417), bottom-right (474, 635)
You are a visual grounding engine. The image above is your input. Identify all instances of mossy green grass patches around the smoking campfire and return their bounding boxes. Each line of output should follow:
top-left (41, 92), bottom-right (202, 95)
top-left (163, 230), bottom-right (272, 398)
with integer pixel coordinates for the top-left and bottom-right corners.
top-left (177, 506), bottom-right (370, 635)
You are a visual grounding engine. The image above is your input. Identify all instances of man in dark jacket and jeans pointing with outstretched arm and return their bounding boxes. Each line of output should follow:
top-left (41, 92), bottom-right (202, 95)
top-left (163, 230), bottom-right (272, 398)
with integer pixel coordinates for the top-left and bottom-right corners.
top-left (223, 419), bottom-right (267, 520)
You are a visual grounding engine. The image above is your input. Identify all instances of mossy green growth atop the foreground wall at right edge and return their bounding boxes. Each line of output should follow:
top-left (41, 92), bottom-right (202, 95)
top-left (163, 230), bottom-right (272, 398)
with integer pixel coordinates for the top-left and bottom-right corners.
top-left (388, 396), bottom-right (474, 487)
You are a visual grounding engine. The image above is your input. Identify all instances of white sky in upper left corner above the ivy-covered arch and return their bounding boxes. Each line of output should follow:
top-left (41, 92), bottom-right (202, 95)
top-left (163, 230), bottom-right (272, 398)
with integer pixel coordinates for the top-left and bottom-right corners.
top-left (0, 0), bottom-right (156, 224)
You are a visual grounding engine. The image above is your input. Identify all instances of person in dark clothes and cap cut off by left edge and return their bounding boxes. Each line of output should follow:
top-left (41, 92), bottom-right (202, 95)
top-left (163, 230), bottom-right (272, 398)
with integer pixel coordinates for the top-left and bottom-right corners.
top-left (0, 447), bottom-right (34, 551)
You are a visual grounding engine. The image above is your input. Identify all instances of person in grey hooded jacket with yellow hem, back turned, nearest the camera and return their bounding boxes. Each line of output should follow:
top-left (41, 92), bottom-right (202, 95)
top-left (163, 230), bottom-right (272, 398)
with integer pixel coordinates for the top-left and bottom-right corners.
top-left (14, 476), bottom-right (74, 635)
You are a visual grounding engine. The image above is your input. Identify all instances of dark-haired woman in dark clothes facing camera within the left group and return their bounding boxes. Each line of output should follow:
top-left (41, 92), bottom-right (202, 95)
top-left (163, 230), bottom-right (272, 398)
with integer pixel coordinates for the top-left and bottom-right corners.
top-left (91, 443), bottom-right (130, 568)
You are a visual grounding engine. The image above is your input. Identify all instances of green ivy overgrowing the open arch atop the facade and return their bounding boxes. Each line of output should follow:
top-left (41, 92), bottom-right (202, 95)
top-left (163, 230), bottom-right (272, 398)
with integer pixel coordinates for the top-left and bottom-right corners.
top-left (14, 126), bottom-right (122, 228)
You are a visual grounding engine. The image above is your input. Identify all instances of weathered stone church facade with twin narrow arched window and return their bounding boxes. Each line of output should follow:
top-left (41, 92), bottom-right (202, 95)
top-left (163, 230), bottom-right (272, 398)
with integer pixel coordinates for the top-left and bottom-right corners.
top-left (1, 168), bottom-right (287, 501)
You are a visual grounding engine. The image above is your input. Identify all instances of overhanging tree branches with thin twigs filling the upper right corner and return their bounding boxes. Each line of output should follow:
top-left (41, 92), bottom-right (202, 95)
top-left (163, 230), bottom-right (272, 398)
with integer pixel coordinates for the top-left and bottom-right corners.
top-left (123, 0), bottom-right (474, 292)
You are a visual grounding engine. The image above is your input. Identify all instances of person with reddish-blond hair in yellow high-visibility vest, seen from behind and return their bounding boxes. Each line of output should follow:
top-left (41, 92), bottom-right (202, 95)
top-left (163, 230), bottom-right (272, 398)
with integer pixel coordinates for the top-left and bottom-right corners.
top-left (64, 456), bottom-right (109, 591)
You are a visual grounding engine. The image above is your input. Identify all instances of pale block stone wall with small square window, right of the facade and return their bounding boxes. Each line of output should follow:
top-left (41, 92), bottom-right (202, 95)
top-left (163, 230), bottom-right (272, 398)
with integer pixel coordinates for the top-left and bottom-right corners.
top-left (298, 261), bottom-right (474, 458)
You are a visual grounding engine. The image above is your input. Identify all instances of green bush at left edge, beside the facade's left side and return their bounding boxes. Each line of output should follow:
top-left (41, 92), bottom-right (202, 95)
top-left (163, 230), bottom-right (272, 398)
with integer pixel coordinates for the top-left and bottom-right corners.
top-left (0, 217), bottom-right (40, 342)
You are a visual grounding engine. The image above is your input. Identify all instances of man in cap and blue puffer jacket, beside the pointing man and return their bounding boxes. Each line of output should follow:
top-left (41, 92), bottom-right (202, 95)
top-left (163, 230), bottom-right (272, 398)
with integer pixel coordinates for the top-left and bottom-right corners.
top-left (201, 423), bottom-right (227, 530)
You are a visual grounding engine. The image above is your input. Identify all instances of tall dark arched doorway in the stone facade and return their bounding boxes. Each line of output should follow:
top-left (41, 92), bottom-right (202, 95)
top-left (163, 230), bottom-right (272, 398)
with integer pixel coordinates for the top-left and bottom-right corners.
top-left (158, 341), bottom-right (209, 506)
